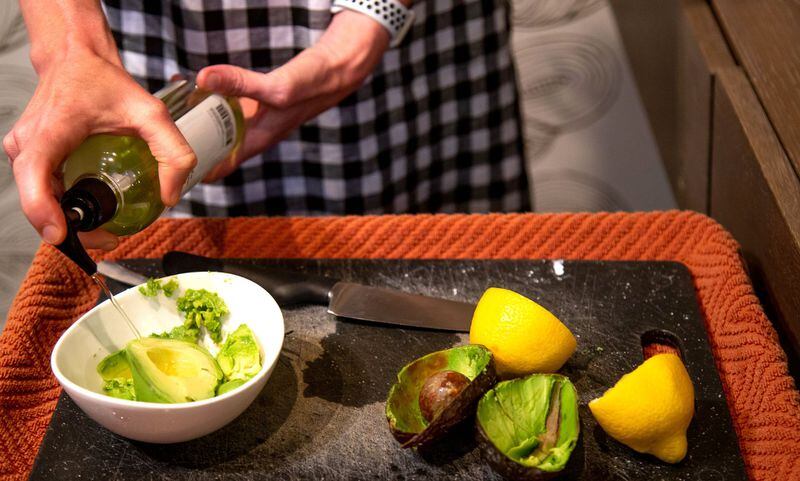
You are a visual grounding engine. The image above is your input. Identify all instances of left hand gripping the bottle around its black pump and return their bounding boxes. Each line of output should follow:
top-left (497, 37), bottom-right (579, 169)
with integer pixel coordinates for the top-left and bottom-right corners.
top-left (3, 46), bottom-right (196, 250)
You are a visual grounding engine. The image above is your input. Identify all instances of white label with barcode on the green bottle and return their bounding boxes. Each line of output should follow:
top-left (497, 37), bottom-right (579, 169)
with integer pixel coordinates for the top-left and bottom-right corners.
top-left (175, 94), bottom-right (236, 194)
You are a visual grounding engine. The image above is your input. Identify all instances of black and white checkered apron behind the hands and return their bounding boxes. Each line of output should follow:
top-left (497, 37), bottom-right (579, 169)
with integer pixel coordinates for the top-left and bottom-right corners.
top-left (104, 0), bottom-right (530, 216)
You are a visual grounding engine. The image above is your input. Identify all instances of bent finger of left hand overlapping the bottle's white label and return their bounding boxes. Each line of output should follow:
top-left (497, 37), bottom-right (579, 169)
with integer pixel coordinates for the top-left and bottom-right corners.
top-left (131, 99), bottom-right (197, 206)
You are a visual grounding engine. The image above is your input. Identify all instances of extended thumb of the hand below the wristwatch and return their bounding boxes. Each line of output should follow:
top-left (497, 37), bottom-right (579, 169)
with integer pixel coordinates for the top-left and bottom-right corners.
top-left (202, 47), bottom-right (341, 109)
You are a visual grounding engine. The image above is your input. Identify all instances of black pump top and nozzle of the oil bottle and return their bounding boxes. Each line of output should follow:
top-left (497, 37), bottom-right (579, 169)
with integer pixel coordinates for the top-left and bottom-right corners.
top-left (56, 178), bottom-right (117, 276)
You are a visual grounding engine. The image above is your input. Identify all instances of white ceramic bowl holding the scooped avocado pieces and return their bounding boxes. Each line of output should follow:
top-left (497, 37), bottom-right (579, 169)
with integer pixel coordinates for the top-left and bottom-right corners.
top-left (50, 272), bottom-right (284, 443)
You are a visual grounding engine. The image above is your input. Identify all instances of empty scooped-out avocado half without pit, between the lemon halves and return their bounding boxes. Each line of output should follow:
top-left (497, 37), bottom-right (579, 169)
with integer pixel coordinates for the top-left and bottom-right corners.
top-left (475, 374), bottom-right (580, 481)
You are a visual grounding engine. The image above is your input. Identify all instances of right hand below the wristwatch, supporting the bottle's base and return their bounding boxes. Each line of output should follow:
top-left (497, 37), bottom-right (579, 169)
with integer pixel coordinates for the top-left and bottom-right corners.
top-left (197, 10), bottom-right (389, 182)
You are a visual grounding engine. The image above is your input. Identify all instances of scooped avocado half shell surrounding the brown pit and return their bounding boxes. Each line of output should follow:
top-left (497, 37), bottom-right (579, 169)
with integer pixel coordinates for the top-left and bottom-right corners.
top-left (386, 344), bottom-right (497, 448)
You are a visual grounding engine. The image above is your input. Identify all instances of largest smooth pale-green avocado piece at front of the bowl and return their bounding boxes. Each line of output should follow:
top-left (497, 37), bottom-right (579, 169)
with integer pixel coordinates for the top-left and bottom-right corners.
top-left (125, 338), bottom-right (222, 403)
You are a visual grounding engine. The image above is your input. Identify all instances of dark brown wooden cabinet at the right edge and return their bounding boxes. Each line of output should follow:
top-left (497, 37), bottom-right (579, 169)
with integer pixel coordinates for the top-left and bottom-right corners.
top-left (611, 0), bottom-right (800, 368)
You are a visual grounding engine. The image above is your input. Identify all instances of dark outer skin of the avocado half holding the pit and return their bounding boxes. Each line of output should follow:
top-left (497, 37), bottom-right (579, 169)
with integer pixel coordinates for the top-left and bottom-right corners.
top-left (392, 358), bottom-right (497, 448)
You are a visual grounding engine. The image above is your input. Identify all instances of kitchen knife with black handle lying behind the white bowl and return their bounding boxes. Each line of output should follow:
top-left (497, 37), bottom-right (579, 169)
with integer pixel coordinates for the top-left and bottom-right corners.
top-left (162, 251), bottom-right (475, 332)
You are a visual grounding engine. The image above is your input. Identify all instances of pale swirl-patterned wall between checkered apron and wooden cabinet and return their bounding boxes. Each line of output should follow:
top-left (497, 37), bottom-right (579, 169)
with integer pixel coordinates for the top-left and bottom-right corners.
top-left (513, 0), bottom-right (675, 212)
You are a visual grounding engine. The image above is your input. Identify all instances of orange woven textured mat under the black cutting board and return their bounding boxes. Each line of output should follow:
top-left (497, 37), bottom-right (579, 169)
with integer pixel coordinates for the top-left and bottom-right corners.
top-left (0, 212), bottom-right (800, 481)
